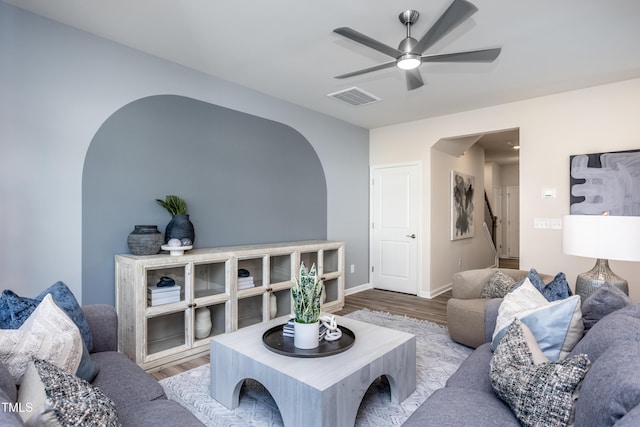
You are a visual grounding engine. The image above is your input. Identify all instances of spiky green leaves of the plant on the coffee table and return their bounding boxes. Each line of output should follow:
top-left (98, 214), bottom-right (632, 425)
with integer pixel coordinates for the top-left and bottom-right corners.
top-left (291, 262), bottom-right (322, 323)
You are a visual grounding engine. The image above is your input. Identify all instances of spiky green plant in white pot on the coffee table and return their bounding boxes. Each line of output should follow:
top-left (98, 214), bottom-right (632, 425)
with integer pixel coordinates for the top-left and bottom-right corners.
top-left (291, 262), bottom-right (322, 349)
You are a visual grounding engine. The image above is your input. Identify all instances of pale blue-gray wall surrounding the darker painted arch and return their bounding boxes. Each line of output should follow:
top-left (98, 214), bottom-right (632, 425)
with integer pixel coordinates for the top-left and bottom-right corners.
top-left (0, 1), bottom-right (369, 303)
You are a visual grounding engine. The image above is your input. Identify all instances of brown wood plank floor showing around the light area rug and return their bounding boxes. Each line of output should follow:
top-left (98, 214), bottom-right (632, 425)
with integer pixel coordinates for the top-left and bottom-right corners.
top-left (151, 289), bottom-right (451, 380)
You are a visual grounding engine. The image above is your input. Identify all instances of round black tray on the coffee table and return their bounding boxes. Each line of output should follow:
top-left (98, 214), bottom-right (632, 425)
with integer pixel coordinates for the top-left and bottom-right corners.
top-left (262, 325), bottom-right (356, 357)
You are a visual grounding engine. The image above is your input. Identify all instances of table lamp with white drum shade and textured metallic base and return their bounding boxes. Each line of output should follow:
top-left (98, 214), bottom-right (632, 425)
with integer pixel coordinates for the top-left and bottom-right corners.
top-left (562, 214), bottom-right (640, 301)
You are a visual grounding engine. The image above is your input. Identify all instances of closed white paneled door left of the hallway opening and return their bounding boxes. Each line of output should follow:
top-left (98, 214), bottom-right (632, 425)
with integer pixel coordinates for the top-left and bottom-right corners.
top-left (371, 164), bottom-right (421, 295)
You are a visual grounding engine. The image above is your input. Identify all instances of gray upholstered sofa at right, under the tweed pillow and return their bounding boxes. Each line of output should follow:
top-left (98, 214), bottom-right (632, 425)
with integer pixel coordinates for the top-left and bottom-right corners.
top-left (404, 299), bottom-right (640, 427)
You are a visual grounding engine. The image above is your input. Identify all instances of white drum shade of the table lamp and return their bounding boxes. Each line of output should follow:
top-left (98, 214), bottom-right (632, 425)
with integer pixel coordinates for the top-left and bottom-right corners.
top-left (562, 215), bottom-right (640, 261)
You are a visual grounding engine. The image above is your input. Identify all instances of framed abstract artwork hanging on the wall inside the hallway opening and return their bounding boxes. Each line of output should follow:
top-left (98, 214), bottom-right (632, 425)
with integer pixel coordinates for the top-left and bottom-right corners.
top-left (451, 170), bottom-right (476, 240)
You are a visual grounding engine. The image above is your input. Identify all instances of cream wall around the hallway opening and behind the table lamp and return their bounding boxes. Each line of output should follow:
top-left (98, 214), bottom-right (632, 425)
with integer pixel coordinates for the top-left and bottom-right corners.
top-left (370, 79), bottom-right (640, 301)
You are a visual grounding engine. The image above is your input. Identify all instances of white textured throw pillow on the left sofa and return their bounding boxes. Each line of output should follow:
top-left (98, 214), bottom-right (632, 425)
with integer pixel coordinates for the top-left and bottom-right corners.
top-left (0, 295), bottom-right (82, 384)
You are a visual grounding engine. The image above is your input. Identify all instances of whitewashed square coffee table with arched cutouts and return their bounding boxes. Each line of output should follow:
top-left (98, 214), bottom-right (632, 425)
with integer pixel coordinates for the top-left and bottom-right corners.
top-left (210, 316), bottom-right (416, 427)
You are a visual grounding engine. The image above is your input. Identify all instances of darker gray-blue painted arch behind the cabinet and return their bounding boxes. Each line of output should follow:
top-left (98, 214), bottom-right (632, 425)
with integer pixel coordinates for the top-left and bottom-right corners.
top-left (82, 95), bottom-right (327, 304)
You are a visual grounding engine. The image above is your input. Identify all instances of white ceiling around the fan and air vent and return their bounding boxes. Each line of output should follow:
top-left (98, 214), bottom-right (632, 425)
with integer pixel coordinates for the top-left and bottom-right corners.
top-left (3, 0), bottom-right (640, 132)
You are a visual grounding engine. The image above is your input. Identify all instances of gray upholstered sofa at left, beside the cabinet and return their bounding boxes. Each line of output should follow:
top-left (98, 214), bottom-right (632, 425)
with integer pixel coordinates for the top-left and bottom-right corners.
top-left (0, 305), bottom-right (203, 427)
